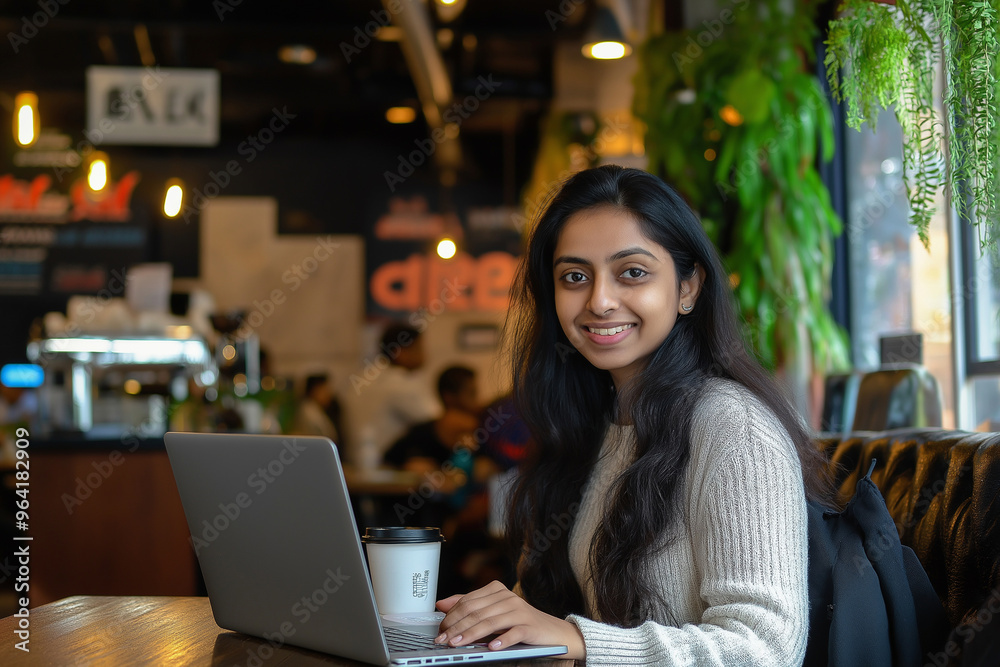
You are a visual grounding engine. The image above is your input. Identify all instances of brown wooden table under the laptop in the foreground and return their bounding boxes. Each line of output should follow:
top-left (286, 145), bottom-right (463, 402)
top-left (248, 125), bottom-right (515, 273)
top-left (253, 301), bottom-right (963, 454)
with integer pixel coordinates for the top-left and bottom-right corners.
top-left (0, 595), bottom-right (572, 667)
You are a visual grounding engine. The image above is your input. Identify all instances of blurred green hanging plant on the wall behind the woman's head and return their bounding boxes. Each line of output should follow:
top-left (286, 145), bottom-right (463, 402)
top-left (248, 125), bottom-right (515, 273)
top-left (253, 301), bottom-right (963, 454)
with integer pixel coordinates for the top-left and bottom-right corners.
top-left (633, 0), bottom-right (849, 380)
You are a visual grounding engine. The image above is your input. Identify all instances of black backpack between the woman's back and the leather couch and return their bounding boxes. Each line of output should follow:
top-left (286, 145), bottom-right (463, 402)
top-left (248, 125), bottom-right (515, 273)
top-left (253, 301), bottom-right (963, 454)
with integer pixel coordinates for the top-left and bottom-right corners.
top-left (804, 460), bottom-right (948, 667)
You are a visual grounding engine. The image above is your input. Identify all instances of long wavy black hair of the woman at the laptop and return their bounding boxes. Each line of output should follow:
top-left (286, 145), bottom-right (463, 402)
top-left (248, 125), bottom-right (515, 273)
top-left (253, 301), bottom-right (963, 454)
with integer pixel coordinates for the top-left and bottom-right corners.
top-left (507, 165), bottom-right (828, 627)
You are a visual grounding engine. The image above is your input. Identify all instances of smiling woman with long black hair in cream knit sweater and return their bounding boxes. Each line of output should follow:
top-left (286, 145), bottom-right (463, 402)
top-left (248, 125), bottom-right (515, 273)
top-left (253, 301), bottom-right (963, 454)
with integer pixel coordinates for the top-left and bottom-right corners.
top-left (438, 166), bottom-right (840, 665)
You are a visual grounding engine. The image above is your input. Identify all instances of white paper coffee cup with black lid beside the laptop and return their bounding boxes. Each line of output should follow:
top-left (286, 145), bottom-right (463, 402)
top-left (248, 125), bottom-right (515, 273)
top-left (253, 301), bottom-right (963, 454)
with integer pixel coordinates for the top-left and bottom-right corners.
top-left (362, 526), bottom-right (444, 614)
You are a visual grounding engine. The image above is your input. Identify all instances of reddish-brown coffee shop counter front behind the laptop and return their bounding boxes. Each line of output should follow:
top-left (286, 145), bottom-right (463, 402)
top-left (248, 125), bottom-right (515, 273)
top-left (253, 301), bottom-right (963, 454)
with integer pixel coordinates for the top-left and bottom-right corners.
top-left (0, 436), bottom-right (201, 607)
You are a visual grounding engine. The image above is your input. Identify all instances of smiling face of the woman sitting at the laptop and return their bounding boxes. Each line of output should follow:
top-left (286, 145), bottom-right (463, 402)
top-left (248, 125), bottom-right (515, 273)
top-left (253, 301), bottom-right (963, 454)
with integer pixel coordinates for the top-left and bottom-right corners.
top-left (552, 206), bottom-right (701, 388)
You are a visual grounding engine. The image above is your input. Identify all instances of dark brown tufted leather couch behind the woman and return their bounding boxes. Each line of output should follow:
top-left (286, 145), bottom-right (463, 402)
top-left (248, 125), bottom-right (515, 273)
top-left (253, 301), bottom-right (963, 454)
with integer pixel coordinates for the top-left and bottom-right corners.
top-left (818, 428), bottom-right (1000, 665)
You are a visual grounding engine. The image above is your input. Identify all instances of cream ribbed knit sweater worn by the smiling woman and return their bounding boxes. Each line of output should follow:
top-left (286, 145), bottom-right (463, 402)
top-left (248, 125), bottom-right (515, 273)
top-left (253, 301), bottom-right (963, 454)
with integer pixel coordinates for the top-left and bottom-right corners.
top-left (567, 380), bottom-right (809, 667)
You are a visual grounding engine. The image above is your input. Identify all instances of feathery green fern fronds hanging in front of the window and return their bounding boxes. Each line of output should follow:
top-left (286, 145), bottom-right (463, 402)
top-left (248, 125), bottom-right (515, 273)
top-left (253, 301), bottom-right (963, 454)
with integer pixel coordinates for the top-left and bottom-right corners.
top-left (826, 0), bottom-right (1000, 247)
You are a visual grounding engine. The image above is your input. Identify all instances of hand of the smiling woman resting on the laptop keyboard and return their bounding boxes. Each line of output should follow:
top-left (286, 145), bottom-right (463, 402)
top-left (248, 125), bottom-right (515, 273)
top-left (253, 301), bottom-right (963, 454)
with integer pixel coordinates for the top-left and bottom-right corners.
top-left (435, 581), bottom-right (587, 660)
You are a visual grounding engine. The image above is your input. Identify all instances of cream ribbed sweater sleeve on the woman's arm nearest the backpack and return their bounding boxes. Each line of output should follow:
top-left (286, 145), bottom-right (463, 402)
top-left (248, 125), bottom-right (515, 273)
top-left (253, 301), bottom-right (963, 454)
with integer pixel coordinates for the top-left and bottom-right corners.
top-left (567, 388), bottom-right (808, 667)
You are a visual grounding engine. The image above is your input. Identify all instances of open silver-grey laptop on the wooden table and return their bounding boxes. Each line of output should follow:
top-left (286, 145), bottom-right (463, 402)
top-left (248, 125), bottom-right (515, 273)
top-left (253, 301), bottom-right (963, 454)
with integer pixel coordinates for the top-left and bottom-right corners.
top-left (163, 433), bottom-right (566, 665)
